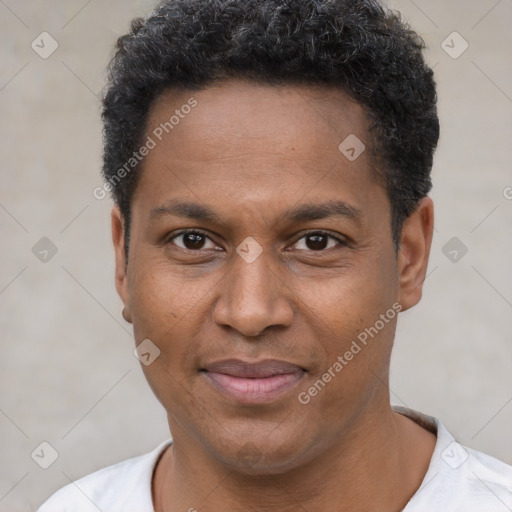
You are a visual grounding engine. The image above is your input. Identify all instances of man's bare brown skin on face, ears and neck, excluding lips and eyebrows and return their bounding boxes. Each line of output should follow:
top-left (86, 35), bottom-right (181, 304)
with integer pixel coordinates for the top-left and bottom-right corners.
top-left (112, 80), bottom-right (435, 512)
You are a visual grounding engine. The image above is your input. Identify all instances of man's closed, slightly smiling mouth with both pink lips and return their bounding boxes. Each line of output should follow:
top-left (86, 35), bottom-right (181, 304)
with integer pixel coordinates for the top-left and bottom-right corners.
top-left (201, 359), bottom-right (306, 404)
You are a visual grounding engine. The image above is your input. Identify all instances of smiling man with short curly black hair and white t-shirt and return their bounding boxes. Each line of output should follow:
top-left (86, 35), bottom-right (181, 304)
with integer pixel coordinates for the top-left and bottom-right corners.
top-left (40, 0), bottom-right (512, 512)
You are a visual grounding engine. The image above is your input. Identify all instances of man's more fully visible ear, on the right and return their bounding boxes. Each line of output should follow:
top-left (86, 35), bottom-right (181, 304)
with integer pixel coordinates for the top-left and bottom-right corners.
top-left (398, 197), bottom-right (434, 311)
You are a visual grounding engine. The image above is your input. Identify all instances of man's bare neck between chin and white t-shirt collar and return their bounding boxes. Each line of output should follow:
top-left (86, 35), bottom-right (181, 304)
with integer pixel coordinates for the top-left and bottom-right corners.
top-left (153, 404), bottom-right (435, 512)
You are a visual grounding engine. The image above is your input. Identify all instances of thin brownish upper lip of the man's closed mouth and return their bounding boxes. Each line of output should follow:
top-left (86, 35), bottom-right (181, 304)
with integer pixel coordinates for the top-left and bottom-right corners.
top-left (204, 359), bottom-right (304, 379)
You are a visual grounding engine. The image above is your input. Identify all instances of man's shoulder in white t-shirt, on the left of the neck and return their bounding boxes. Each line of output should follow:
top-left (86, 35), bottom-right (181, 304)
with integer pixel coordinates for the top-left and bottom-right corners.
top-left (38, 440), bottom-right (171, 512)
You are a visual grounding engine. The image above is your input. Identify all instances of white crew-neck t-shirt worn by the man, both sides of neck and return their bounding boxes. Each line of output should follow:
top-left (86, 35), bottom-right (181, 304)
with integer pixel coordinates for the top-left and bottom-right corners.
top-left (38, 407), bottom-right (512, 512)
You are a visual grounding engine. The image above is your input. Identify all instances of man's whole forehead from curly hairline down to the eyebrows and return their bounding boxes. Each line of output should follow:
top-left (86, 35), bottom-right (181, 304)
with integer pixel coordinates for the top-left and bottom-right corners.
top-left (134, 80), bottom-right (384, 224)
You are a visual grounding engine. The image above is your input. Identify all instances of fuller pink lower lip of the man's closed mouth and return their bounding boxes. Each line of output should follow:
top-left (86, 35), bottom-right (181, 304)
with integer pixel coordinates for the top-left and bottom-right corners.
top-left (204, 372), bottom-right (304, 404)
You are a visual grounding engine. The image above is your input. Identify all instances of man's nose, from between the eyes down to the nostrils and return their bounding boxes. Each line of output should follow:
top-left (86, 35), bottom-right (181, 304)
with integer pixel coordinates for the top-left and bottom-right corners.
top-left (213, 254), bottom-right (293, 337)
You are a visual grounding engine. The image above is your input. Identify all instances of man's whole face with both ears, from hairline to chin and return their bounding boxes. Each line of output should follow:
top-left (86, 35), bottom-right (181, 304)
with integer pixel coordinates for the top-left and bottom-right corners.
top-left (112, 81), bottom-right (431, 473)
